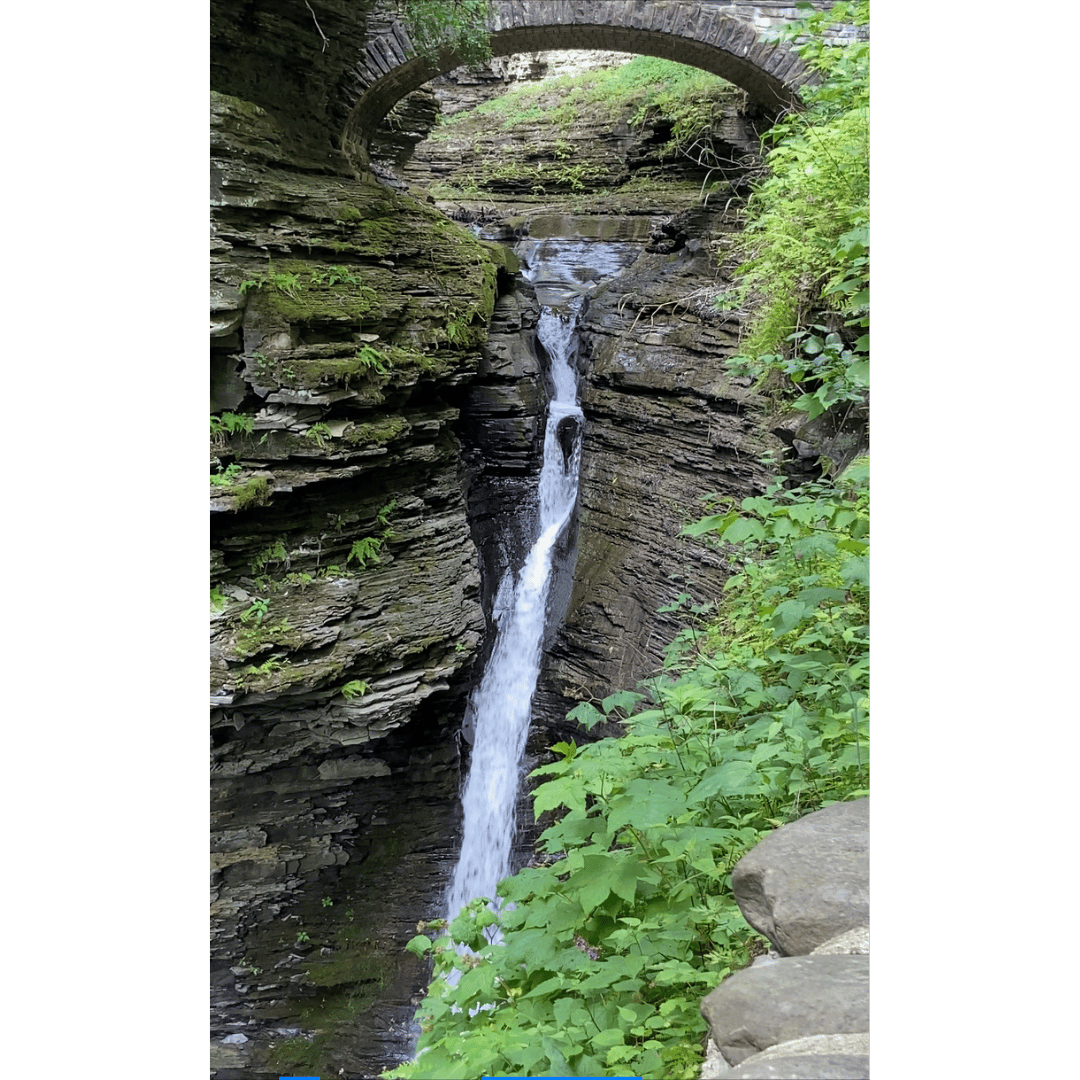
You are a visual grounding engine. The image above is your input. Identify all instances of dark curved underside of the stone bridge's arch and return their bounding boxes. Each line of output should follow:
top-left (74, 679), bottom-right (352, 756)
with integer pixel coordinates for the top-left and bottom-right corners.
top-left (341, 19), bottom-right (807, 171)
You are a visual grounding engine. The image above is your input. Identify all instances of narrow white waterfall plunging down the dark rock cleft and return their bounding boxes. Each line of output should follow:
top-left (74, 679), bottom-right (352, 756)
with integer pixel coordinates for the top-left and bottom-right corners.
top-left (446, 296), bottom-right (583, 919)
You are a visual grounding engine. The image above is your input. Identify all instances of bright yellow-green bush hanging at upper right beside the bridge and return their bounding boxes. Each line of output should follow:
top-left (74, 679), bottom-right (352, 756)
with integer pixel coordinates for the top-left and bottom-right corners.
top-left (717, 0), bottom-right (870, 417)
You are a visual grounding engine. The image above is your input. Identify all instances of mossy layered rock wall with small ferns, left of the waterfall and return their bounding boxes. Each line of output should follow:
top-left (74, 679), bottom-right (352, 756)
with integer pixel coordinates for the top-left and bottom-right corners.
top-left (210, 69), bottom-right (513, 1080)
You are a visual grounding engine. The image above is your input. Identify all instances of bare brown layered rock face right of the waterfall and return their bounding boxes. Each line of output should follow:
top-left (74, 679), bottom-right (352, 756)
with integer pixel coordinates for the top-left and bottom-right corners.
top-left (532, 206), bottom-right (781, 752)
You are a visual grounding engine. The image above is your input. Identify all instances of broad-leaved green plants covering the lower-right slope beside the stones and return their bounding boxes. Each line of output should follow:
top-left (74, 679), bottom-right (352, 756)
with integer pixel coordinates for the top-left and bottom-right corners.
top-left (387, 462), bottom-right (869, 1080)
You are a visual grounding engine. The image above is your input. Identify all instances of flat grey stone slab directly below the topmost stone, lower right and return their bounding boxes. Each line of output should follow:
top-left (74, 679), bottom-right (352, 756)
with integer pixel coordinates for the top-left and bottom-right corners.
top-left (701, 956), bottom-right (870, 1062)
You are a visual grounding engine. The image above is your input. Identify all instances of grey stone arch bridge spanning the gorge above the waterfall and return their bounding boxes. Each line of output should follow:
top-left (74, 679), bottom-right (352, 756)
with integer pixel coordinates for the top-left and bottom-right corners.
top-left (341, 0), bottom-right (846, 168)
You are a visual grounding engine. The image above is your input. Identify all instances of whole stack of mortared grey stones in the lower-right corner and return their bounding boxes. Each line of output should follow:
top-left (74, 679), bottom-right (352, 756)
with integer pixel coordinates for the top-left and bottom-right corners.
top-left (701, 798), bottom-right (870, 1080)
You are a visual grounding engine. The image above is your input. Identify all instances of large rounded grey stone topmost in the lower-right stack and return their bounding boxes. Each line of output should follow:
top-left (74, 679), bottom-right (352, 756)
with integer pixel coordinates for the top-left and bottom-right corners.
top-left (731, 798), bottom-right (870, 956)
